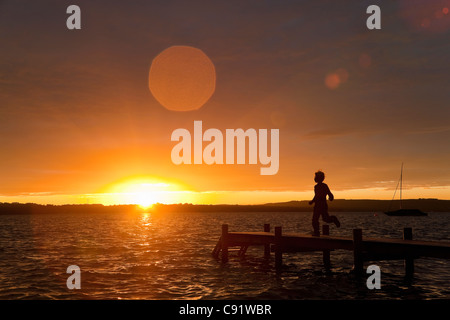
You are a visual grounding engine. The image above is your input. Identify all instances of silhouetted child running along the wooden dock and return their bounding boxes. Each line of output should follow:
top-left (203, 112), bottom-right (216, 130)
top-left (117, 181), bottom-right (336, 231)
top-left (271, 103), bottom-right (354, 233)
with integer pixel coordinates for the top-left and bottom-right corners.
top-left (309, 170), bottom-right (341, 236)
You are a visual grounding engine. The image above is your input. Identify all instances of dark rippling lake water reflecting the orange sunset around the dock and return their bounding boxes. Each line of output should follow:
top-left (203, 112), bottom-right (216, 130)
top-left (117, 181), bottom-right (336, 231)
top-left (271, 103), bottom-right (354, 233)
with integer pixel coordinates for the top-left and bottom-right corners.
top-left (0, 212), bottom-right (450, 300)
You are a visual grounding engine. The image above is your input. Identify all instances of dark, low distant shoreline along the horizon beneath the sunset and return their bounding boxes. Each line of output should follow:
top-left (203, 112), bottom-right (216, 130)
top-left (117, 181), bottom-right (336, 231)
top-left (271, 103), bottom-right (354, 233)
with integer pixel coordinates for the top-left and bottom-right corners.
top-left (0, 199), bottom-right (450, 215)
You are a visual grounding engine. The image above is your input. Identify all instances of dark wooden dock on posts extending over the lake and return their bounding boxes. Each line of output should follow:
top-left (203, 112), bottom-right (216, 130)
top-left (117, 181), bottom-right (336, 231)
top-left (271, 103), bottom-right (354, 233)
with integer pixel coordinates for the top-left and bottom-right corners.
top-left (212, 224), bottom-right (450, 277)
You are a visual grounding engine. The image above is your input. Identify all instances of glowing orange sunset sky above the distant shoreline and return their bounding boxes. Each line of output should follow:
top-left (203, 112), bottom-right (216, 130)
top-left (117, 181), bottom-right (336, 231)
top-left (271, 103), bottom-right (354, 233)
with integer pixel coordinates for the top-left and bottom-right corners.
top-left (0, 0), bottom-right (450, 204)
